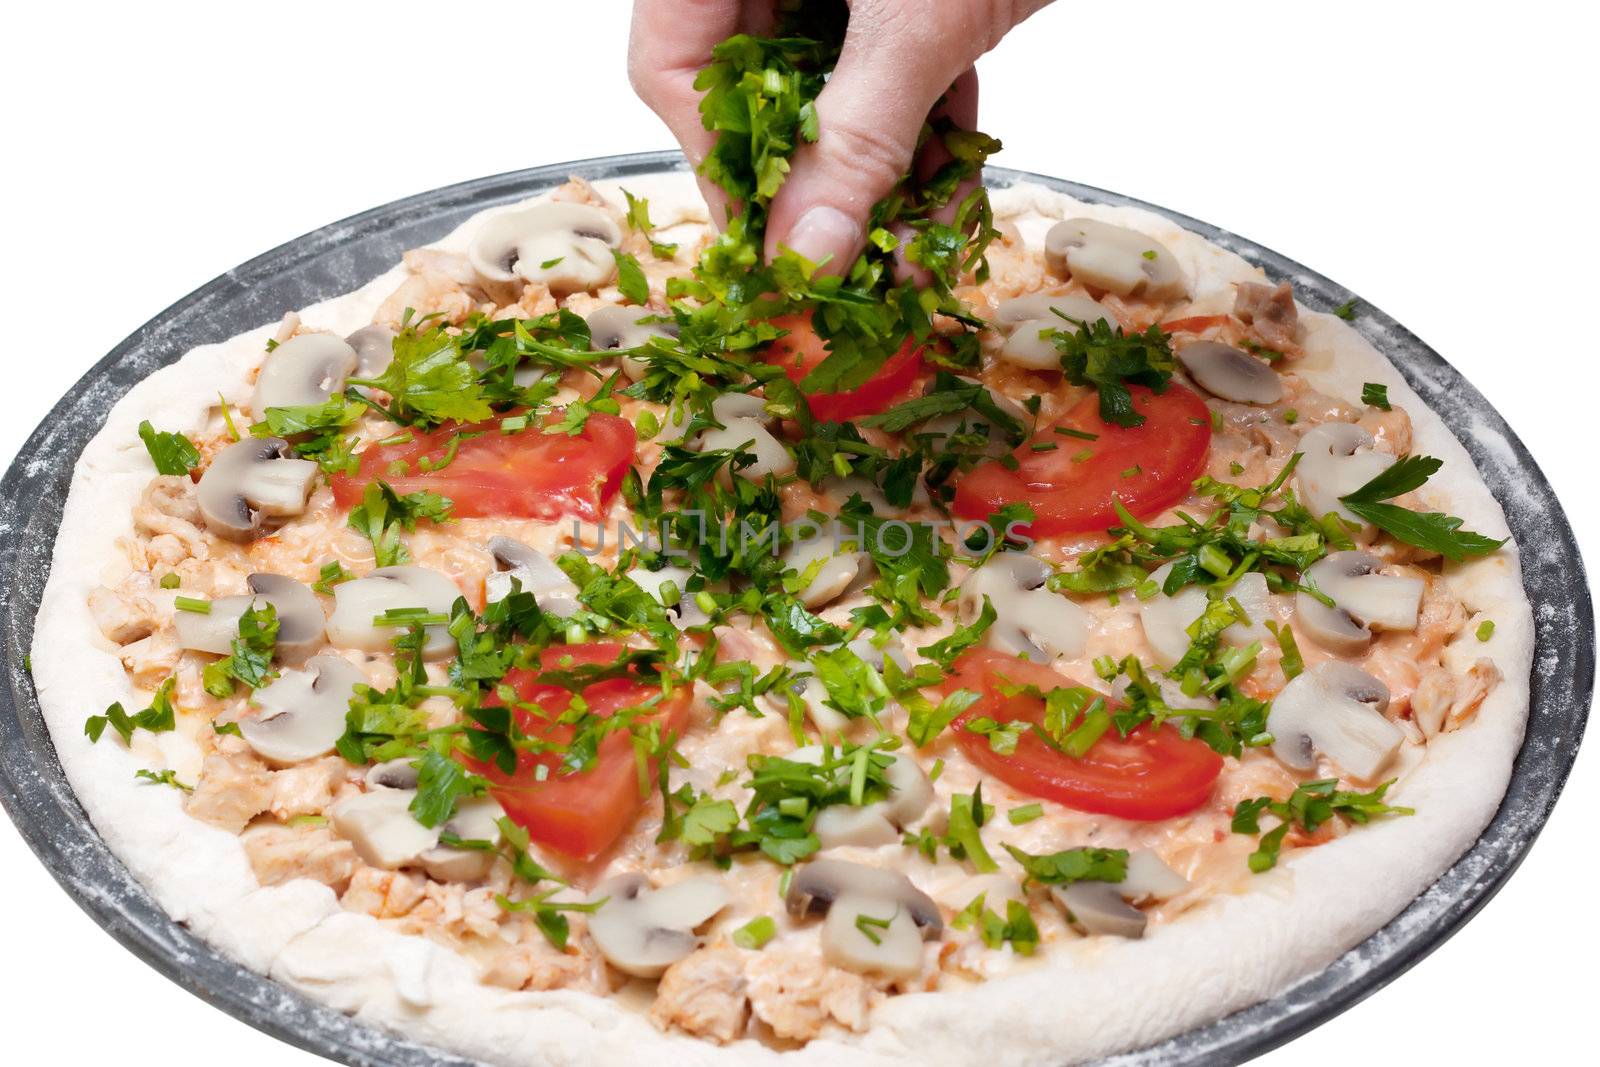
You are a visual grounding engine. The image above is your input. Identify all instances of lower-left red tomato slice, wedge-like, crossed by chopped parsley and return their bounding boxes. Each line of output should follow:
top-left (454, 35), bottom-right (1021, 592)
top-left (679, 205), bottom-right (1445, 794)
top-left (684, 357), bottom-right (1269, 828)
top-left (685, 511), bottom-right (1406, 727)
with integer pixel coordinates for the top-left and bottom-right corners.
top-left (466, 643), bottom-right (690, 859)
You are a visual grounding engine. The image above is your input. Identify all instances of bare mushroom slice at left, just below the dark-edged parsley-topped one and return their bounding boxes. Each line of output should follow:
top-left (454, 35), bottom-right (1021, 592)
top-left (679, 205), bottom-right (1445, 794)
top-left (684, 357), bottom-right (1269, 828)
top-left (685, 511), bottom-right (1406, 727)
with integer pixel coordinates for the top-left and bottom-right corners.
top-left (238, 656), bottom-right (366, 763)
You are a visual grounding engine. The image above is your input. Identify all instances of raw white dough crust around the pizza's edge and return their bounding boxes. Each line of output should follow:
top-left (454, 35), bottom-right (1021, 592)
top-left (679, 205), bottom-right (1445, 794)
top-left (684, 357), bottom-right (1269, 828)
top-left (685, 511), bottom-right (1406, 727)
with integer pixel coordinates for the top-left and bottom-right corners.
top-left (32, 173), bottom-right (1533, 1065)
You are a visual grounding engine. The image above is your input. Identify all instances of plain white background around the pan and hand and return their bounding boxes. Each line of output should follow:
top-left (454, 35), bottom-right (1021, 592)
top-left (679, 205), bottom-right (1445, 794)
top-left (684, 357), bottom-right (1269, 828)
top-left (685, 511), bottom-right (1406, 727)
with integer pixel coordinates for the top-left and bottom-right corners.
top-left (0, 0), bottom-right (1600, 1067)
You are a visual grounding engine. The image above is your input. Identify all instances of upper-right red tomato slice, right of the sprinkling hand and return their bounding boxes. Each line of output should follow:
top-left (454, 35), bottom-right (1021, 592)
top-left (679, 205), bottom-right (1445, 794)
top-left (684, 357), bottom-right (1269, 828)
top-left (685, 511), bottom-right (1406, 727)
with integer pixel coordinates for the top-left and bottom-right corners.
top-left (954, 382), bottom-right (1211, 537)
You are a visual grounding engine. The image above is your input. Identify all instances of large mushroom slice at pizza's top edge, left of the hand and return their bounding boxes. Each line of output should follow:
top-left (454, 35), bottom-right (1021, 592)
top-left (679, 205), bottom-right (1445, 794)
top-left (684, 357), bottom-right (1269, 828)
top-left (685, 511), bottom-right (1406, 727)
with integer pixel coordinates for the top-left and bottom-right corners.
top-left (467, 202), bottom-right (622, 293)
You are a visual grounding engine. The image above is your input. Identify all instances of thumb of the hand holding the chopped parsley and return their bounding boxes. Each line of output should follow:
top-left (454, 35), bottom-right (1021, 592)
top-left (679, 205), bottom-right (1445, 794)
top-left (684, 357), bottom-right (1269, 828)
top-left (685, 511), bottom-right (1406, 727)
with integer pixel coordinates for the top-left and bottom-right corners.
top-left (766, 10), bottom-right (973, 274)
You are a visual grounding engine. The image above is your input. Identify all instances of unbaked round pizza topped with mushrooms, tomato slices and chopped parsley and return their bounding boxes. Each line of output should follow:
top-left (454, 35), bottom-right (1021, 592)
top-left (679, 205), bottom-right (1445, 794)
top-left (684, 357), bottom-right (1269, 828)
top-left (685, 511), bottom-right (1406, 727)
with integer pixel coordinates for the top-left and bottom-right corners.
top-left (21, 18), bottom-right (1533, 1064)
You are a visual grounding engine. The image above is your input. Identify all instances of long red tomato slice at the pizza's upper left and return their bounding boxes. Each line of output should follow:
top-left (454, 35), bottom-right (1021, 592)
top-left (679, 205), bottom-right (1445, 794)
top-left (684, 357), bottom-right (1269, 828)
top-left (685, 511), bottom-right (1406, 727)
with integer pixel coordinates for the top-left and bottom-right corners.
top-left (333, 414), bottom-right (638, 522)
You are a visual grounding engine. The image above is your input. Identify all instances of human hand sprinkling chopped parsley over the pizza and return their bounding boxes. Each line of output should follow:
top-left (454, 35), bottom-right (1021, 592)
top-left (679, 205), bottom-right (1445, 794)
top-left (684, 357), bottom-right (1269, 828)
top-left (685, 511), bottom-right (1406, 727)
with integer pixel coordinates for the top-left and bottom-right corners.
top-left (627, 0), bottom-right (1050, 269)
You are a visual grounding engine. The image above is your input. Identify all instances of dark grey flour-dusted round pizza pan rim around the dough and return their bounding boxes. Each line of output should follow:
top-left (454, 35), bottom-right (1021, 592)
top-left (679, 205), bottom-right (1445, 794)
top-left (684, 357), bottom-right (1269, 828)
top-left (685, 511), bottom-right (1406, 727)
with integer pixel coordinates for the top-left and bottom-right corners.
top-left (0, 152), bottom-right (1595, 1067)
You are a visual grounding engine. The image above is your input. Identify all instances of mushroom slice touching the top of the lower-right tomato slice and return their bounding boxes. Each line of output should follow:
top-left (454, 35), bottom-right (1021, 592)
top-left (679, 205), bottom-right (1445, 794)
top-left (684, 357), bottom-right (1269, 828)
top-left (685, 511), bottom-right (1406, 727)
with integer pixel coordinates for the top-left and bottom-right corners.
top-left (957, 552), bottom-right (1090, 662)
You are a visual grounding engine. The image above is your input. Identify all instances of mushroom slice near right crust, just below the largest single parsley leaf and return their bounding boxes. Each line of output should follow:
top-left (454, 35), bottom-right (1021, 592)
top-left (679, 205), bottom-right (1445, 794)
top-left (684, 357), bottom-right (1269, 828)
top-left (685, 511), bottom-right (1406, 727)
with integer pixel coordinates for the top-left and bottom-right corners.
top-left (1294, 552), bottom-right (1427, 653)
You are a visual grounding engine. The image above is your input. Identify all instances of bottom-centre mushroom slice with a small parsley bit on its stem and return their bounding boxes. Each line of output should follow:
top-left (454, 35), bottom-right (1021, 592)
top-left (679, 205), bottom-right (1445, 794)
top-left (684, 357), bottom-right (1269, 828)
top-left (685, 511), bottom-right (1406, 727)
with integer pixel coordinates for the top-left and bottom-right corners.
top-left (784, 859), bottom-right (944, 977)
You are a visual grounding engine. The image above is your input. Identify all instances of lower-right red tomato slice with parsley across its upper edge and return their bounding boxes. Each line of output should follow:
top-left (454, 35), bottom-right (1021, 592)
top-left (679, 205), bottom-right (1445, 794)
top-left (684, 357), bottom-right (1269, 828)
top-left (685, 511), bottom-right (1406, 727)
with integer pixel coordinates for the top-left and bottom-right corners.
top-left (946, 648), bottom-right (1222, 821)
